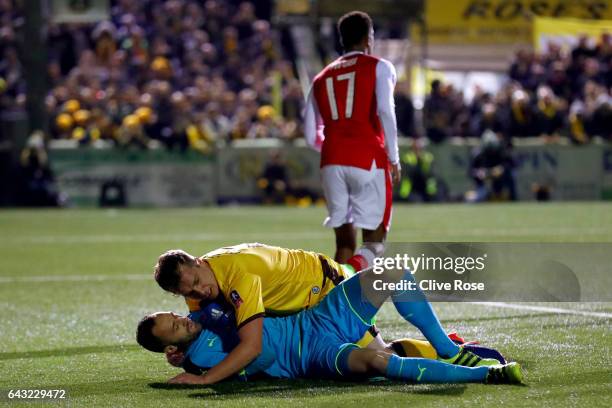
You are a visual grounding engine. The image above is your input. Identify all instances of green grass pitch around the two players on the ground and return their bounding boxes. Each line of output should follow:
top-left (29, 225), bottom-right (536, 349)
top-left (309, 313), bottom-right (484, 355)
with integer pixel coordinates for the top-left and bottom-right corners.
top-left (0, 203), bottom-right (612, 408)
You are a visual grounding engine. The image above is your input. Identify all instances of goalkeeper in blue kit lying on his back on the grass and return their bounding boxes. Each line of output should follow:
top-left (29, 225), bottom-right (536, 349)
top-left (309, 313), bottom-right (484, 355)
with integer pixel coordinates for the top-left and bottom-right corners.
top-left (137, 269), bottom-right (522, 384)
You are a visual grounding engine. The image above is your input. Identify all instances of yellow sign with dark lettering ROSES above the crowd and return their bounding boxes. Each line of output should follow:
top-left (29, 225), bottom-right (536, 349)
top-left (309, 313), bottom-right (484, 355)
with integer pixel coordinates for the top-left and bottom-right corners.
top-left (413, 0), bottom-right (612, 44)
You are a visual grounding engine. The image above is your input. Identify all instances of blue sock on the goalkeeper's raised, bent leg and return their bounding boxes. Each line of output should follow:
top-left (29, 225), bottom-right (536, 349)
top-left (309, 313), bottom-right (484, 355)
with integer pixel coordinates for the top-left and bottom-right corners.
top-left (392, 271), bottom-right (460, 358)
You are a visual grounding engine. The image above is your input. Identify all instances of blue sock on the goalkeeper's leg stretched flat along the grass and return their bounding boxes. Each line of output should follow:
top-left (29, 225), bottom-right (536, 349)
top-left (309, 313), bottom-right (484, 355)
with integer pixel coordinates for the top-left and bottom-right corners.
top-left (385, 354), bottom-right (489, 383)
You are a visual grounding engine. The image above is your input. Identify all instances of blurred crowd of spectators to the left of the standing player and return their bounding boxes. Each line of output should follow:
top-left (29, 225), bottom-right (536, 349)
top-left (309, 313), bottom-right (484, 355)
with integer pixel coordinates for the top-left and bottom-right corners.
top-left (0, 0), bottom-right (302, 151)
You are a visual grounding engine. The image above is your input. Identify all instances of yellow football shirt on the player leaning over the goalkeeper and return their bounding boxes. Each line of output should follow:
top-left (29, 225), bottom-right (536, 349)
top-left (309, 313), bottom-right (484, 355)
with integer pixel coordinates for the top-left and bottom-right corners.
top-left (186, 243), bottom-right (347, 328)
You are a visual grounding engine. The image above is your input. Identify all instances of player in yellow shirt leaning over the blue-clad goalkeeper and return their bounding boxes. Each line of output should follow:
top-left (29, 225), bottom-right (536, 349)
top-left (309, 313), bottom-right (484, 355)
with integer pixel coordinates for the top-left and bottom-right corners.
top-left (155, 243), bottom-right (504, 381)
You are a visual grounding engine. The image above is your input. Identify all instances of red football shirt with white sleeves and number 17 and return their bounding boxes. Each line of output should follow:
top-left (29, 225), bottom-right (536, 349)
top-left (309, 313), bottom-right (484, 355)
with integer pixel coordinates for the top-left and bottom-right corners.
top-left (304, 52), bottom-right (399, 169)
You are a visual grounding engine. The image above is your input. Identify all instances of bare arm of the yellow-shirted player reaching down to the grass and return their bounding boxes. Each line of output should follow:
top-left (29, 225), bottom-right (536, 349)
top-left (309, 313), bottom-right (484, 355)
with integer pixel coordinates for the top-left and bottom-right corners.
top-left (197, 317), bottom-right (264, 384)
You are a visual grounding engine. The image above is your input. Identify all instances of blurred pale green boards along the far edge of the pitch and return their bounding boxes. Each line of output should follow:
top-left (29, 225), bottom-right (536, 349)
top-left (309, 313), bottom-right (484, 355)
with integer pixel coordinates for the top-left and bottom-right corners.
top-left (50, 140), bottom-right (612, 207)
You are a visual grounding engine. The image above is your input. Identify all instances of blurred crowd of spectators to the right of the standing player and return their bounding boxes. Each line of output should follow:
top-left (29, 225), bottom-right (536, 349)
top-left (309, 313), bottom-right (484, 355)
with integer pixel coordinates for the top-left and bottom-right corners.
top-left (424, 34), bottom-right (612, 143)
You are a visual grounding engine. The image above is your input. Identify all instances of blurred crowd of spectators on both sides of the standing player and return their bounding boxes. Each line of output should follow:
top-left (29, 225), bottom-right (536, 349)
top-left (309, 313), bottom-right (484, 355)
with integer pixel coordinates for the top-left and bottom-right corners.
top-left (0, 0), bottom-right (612, 152)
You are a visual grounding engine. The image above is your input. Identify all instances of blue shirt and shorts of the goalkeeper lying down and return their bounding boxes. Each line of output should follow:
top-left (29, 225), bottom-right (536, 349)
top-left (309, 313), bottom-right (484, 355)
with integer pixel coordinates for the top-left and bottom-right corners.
top-left (186, 275), bottom-right (378, 378)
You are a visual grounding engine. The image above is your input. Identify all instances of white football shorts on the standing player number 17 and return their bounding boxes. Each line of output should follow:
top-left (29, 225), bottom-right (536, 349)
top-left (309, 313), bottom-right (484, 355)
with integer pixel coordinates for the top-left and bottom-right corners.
top-left (321, 165), bottom-right (392, 230)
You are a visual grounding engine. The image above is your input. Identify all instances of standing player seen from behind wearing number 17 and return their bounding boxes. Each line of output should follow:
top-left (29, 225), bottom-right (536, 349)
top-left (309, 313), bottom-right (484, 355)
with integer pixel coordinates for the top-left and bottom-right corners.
top-left (304, 11), bottom-right (401, 270)
